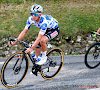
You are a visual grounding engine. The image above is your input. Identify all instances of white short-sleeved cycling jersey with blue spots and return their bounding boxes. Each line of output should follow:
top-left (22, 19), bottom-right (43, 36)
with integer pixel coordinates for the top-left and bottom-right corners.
top-left (25, 15), bottom-right (58, 35)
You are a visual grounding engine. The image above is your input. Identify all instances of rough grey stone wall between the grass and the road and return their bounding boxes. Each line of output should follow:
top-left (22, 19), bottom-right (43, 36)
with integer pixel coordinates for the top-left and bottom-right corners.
top-left (0, 35), bottom-right (99, 57)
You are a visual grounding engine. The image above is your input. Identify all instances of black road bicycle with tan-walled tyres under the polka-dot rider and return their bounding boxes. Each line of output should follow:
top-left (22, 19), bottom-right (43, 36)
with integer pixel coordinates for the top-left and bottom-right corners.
top-left (1, 38), bottom-right (64, 88)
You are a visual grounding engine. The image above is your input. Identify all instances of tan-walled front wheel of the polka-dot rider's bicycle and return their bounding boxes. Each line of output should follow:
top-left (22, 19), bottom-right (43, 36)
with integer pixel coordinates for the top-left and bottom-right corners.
top-left (1, 52), bottom-right (29, 88)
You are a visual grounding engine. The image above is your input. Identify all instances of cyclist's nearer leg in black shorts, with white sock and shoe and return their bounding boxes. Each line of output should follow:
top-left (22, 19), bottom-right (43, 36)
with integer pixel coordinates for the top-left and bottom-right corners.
top-left (36, 28), bottom-right (59, 65)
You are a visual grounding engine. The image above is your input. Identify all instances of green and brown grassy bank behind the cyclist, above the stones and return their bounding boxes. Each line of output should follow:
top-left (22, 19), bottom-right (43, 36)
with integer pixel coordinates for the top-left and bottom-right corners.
top-left (0, 0), bottom-right (100, 42)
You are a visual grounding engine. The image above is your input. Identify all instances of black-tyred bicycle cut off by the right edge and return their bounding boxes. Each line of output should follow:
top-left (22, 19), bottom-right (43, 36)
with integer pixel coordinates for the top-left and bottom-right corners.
top-left (85, 32), bottom-right (100, 69)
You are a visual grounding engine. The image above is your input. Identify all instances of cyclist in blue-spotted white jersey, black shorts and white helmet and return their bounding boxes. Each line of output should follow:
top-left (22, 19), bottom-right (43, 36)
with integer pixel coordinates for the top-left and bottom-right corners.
top-left (11, 4), bottom-right (59, 65)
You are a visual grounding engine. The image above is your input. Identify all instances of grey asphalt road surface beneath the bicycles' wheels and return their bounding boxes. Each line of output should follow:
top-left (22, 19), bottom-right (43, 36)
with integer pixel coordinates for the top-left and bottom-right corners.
top-left (0, 55), bottom-right (100, 90)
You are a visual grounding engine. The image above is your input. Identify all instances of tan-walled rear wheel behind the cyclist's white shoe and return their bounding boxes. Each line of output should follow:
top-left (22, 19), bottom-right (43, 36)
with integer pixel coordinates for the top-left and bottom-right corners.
top-left (41, 48), bottom-right (64, 79)
